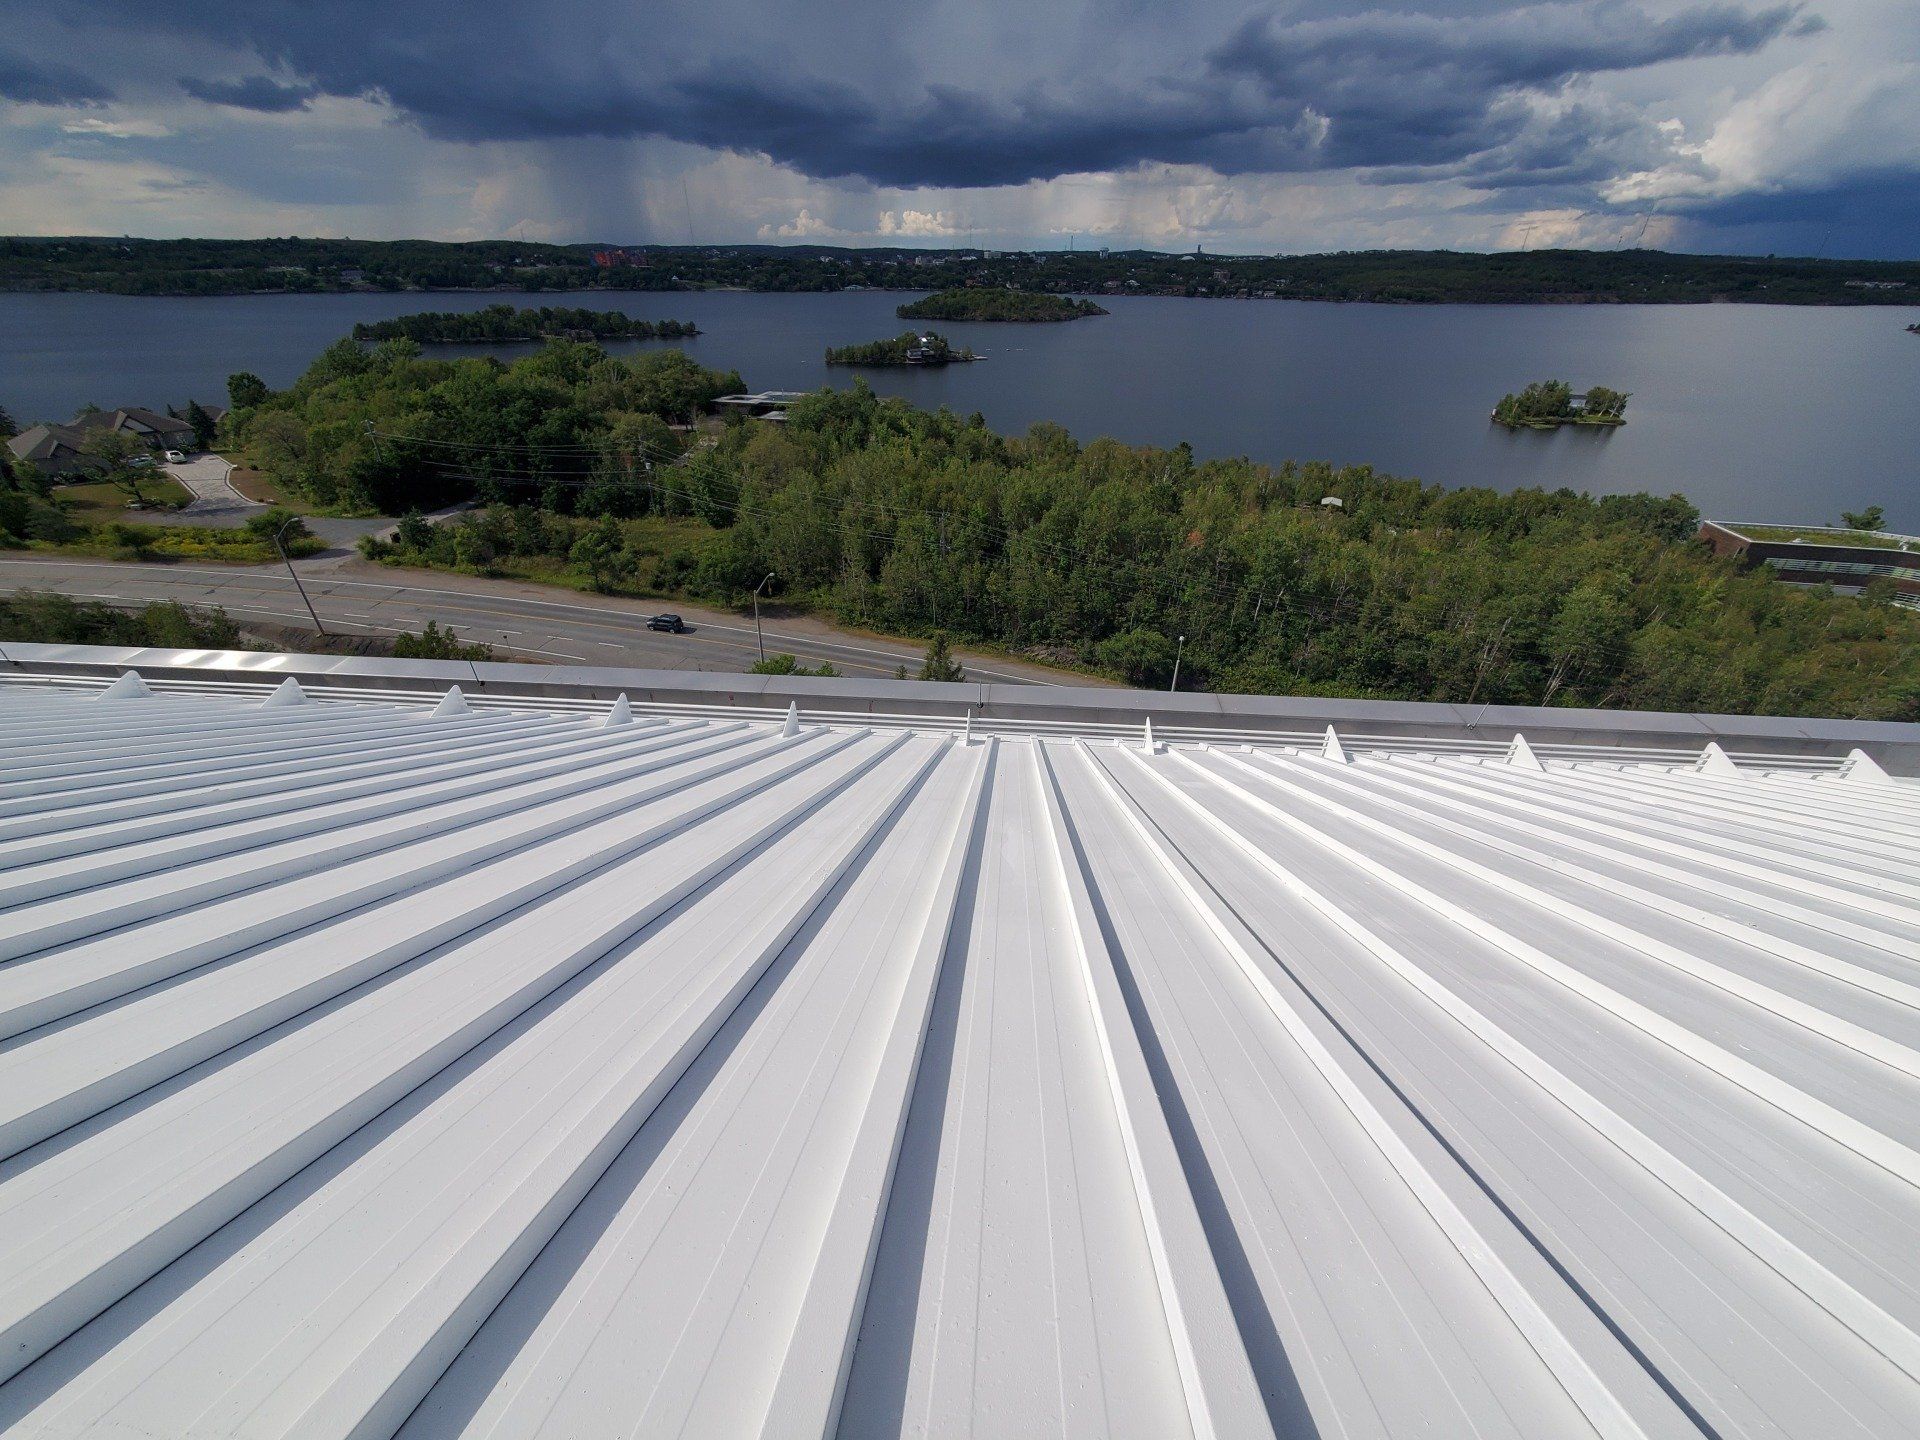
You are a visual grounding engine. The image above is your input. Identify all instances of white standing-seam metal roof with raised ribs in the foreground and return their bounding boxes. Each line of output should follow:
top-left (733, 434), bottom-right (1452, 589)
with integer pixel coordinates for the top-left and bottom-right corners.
top-left (0, 685), bottom-right (1920, 1440)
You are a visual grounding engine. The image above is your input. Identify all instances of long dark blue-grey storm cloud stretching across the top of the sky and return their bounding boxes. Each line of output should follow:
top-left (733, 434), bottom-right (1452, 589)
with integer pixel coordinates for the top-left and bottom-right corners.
top-left (37, 0), bottom-right (1818, 188)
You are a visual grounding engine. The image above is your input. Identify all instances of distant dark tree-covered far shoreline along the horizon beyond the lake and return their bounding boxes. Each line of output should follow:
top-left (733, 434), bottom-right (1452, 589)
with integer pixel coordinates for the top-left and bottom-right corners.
top-left (0, 236), bottom-right (1920, 305)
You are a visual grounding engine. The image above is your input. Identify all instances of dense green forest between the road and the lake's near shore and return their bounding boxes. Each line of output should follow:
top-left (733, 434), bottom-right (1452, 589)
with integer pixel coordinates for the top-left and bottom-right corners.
top-left (210, 342), bottom-right (1920, 720)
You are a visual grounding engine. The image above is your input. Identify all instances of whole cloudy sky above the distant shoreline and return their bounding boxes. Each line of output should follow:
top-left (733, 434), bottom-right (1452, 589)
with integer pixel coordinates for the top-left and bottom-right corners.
top-left (0, 0), bottom-right (1920, 259)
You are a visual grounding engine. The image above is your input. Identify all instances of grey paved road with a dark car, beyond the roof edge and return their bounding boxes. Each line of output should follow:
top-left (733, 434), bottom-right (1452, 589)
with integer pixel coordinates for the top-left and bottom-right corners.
top-left (0, 557), bottom-right (1096, 684)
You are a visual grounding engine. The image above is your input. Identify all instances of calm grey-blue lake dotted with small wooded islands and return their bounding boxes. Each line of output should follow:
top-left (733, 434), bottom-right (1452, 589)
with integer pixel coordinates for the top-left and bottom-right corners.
top-left (0, 292), bottom-right (1920, 530)
